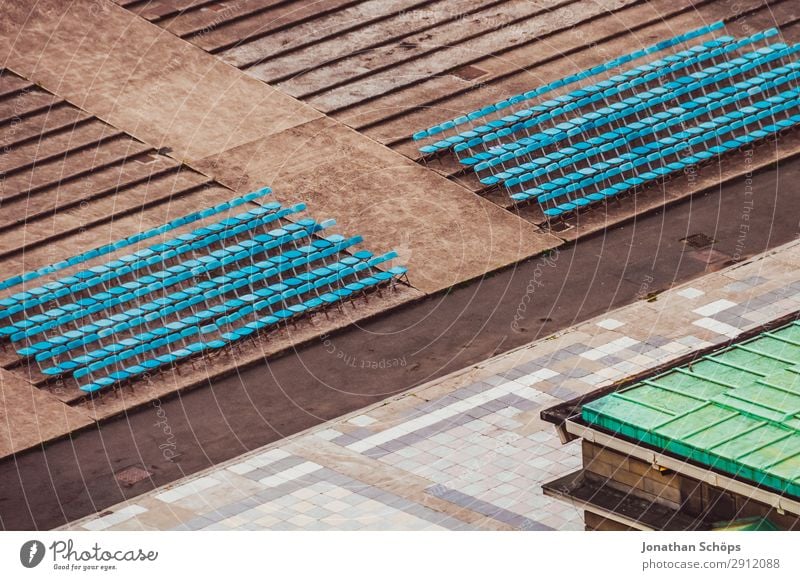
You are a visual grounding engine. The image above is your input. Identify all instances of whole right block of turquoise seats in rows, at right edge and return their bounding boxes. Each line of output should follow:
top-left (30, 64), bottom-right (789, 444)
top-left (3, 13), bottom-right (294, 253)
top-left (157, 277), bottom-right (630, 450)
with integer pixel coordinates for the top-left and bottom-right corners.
top-left (413, 22), bottom-right (800, 223)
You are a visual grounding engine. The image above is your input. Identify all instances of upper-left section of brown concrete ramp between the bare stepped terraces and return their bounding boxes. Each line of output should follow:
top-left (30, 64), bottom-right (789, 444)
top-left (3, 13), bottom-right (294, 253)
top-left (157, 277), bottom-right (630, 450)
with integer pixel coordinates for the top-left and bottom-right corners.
top-left (0, 0), bottom-right (320, 160)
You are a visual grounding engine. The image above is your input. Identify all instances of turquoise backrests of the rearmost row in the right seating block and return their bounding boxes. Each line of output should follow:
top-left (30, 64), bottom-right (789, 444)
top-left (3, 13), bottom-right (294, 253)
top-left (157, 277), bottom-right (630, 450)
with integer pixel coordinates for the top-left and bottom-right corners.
top-left (412, 22), bottom-right (724, 141)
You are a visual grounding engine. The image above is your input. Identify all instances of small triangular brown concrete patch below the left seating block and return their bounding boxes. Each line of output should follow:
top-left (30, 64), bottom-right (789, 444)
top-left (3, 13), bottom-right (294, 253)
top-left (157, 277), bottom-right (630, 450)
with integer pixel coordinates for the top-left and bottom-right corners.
top-left (0, 368), bottom-right (94, 457)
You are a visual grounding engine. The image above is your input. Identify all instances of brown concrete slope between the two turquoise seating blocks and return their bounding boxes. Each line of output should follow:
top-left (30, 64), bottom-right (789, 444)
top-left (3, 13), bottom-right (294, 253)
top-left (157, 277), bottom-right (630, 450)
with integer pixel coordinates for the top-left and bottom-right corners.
top-left (195, 118), bottom-right (562, 293)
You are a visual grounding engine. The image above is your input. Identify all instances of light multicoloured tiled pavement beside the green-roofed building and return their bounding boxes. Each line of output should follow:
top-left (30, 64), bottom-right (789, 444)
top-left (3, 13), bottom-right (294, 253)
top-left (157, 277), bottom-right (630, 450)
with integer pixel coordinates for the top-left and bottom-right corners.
top-left (69, 242), bottom-right (800, 530)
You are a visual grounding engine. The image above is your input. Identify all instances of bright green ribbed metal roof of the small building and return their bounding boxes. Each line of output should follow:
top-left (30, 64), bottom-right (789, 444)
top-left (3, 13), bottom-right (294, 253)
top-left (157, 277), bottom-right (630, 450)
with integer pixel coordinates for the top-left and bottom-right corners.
top-left (582, 323), bottom-right (800, 497)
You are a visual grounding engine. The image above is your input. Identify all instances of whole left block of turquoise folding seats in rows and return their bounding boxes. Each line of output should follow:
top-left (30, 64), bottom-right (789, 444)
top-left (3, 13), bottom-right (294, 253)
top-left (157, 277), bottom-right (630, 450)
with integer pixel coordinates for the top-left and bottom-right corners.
top-left (0, 188), bottom-right (406, 394)
